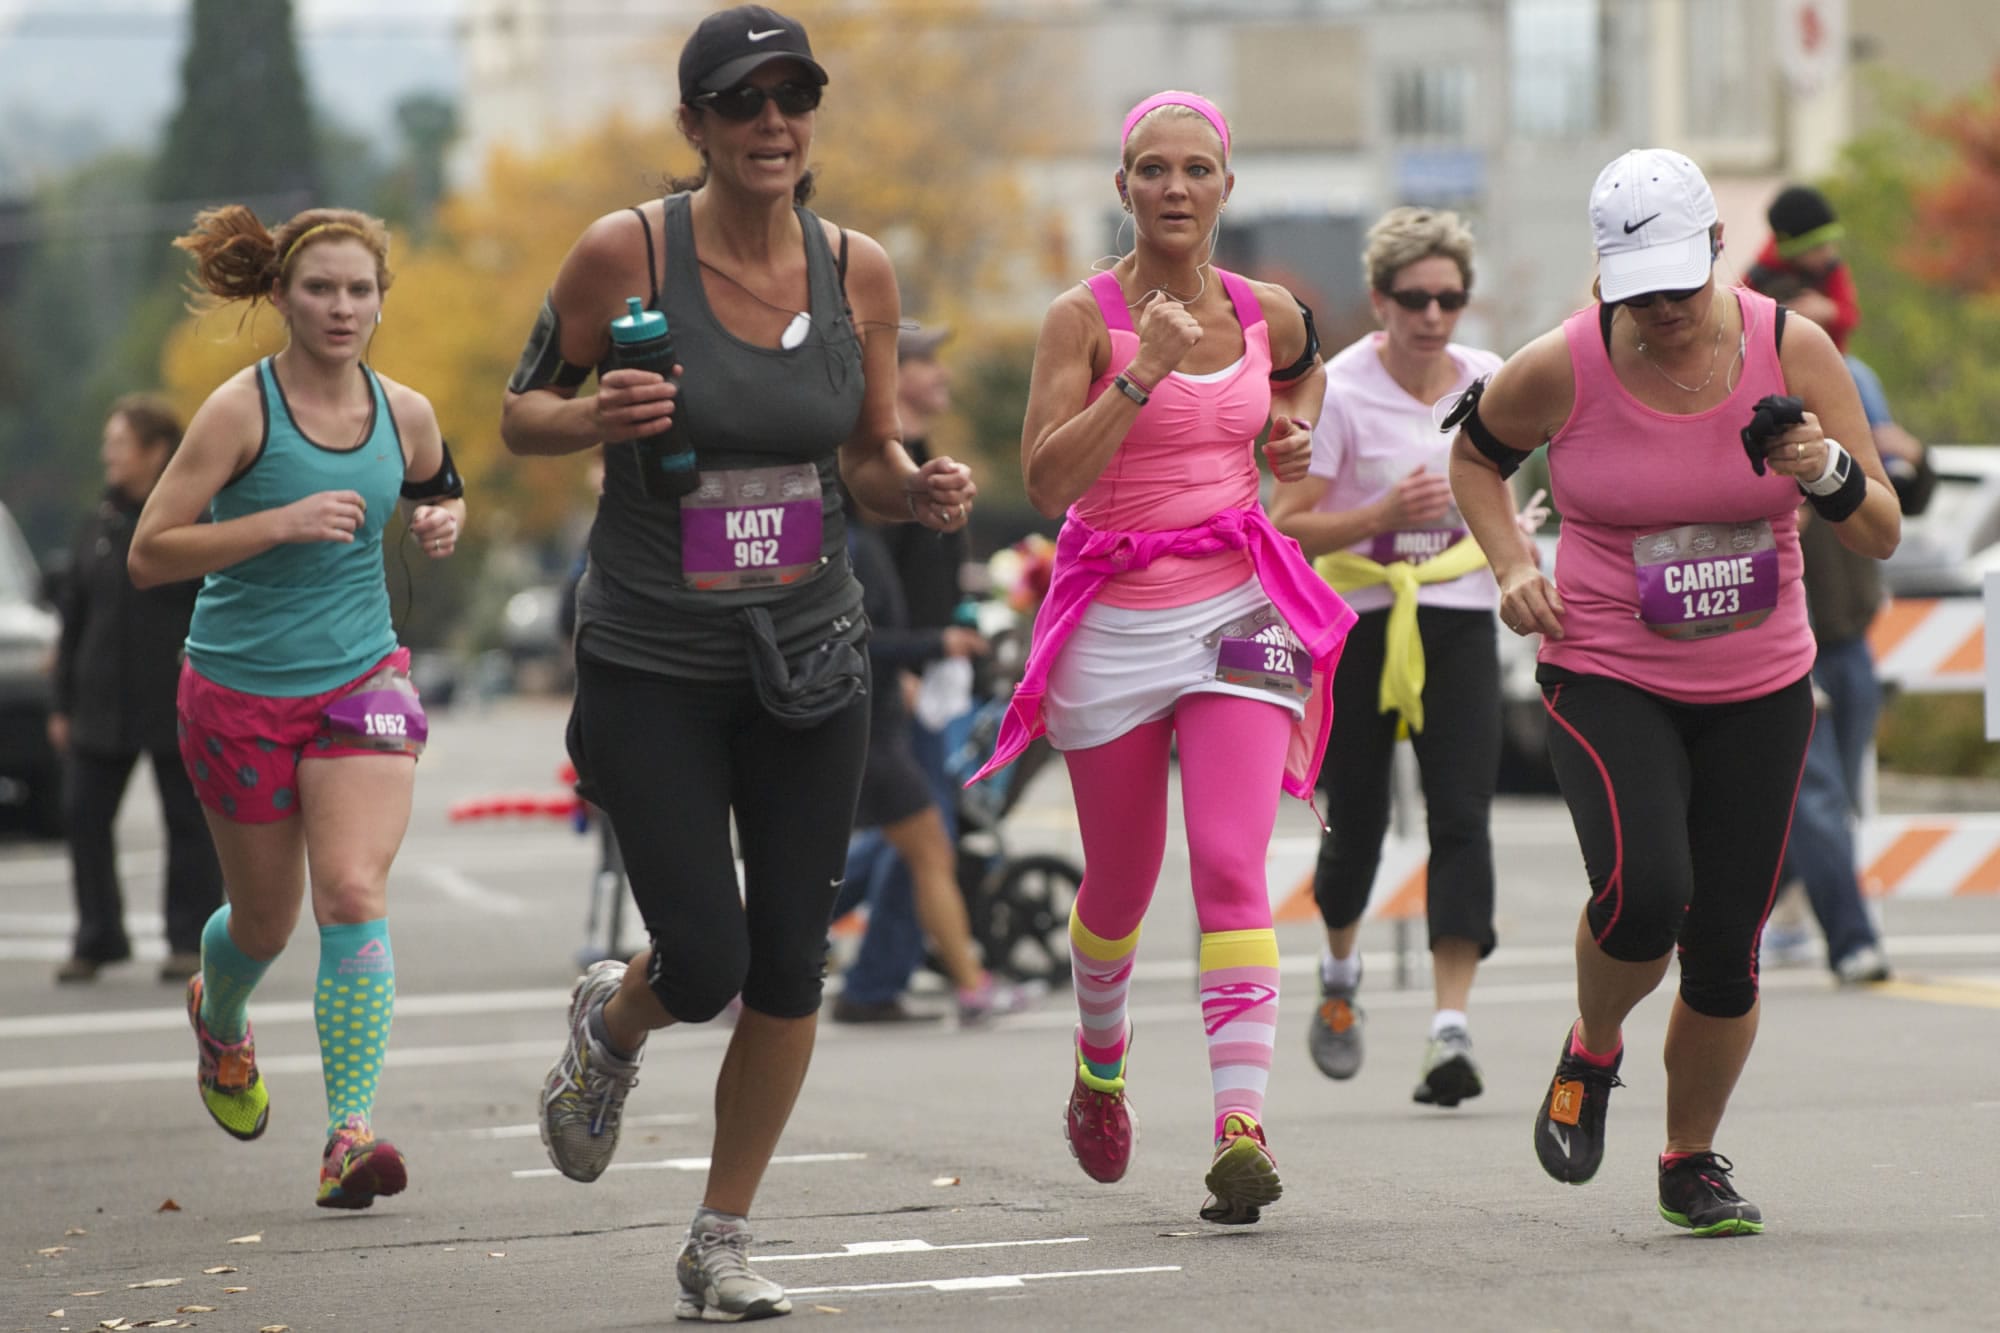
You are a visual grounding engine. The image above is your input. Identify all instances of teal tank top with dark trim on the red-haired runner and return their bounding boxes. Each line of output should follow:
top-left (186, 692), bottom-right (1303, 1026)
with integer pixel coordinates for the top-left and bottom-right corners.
top-left (188, 356), bottom-right (404, 699)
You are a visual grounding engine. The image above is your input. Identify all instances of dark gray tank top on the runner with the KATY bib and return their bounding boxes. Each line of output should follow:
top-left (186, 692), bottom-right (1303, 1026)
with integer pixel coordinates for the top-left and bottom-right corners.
top-left (576, 194), bottom-right (866, 681)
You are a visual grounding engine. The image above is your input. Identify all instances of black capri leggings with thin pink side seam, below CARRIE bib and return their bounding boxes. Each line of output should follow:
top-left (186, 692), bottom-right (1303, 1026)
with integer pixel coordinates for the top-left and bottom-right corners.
top-left (1536, 667), bottom-right (1812, 1019)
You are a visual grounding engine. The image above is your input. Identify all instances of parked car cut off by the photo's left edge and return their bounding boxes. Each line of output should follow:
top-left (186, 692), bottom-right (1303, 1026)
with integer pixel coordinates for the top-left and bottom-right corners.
top-left (0, 506), bottom-right (62, 837)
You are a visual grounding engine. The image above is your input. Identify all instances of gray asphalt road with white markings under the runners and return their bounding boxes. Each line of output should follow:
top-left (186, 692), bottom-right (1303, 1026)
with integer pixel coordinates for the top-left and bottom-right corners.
top-left (0, 701), bottom-right (2000, 1333)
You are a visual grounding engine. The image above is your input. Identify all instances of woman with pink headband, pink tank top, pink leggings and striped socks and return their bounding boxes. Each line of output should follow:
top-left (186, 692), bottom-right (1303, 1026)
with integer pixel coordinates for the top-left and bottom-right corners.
top-left (994, 83), bottom-right (1354, 1225)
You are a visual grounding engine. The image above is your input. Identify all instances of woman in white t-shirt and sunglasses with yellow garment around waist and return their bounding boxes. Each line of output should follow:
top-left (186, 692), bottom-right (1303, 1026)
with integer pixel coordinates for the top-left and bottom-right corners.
top-left (1270, 208), bottom-right (1500, 1107)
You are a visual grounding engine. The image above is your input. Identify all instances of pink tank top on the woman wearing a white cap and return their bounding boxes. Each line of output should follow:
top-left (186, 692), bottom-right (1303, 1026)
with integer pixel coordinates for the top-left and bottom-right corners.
top-left (1540, 288), bottom-right (1814, 705)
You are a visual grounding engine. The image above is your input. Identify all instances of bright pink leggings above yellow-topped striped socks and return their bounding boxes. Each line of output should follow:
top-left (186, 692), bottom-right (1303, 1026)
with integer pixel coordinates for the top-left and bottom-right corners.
top-left (1064, 693), bottom-right (1292, 941)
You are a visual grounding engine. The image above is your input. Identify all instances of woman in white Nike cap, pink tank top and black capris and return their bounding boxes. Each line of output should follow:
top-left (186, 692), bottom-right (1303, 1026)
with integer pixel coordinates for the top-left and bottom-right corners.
top-left (1446, 148), bottom-right (1900, 1235)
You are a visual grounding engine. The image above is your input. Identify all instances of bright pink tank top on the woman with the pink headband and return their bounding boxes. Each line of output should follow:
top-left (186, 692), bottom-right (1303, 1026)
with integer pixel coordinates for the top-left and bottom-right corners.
top-left (1072, 268), bottom-right (1270, 608)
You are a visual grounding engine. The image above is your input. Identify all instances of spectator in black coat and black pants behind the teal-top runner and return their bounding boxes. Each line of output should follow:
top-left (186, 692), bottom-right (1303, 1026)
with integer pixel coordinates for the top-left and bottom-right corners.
top-left (48, 394), bottom-right (222, 983)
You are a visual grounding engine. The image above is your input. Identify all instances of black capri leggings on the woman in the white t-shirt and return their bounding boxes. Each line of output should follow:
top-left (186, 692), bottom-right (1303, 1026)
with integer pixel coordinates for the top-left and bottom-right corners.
top-left (1312, 606), bottom-right (1500, 959)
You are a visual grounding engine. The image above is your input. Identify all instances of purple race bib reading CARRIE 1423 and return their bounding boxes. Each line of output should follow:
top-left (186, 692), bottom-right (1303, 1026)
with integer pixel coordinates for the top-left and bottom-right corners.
top-left (1632, 518), bottom-right (1778, 638)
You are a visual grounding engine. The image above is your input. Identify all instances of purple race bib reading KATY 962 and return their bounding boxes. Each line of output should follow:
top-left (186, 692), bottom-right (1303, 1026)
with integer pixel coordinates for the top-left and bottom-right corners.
top-left (680, 462), bottom-right (824, 592)
